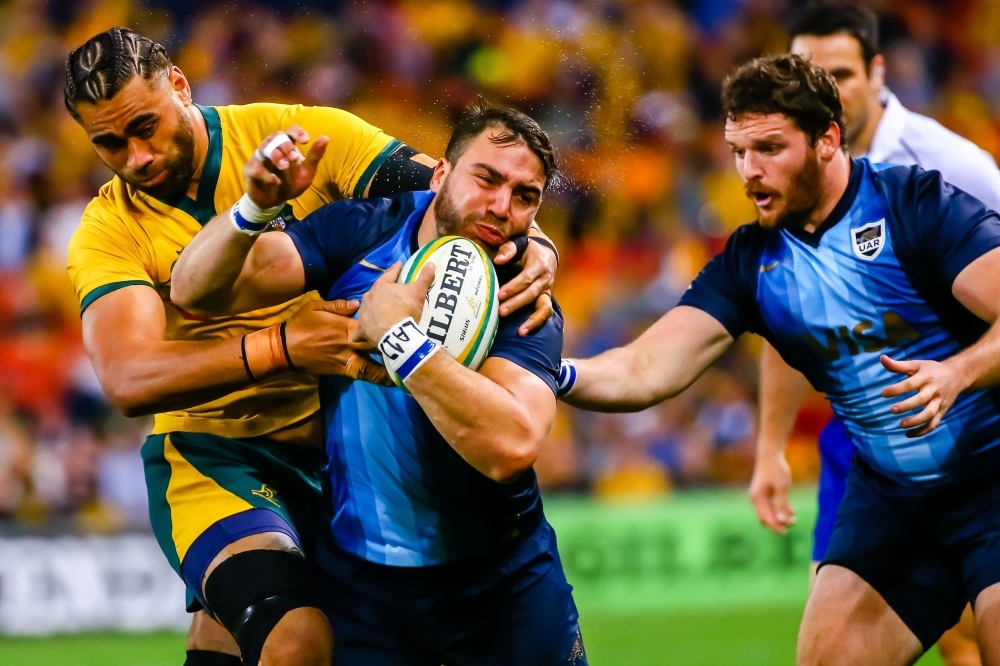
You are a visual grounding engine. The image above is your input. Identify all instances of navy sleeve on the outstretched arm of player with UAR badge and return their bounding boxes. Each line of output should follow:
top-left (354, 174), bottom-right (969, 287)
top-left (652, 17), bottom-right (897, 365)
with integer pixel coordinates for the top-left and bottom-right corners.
top-left (678, 224), bottom-right (766, 339)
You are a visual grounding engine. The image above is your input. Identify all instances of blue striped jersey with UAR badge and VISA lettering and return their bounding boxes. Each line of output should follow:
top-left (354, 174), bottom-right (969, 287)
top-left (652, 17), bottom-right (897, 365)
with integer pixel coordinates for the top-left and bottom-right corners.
top-left (681, 159), bottom-right (1000, 485)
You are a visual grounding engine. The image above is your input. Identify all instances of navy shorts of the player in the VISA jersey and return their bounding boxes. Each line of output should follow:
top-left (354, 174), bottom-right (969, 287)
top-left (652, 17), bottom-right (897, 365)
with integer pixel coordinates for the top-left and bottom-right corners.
top-left (821, 456), bottom-right (1000, 650)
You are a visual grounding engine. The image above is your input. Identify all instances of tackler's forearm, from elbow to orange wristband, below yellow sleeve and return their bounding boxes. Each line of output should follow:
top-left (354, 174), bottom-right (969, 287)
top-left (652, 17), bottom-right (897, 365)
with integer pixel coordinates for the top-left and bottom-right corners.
top-left (88, 338), bottom-right (252, 416)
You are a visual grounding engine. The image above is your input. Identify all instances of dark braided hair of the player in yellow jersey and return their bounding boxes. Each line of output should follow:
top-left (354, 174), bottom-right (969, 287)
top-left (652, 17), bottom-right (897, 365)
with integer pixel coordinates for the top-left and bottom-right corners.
top-left (63, 28), bottom-right (171, 118)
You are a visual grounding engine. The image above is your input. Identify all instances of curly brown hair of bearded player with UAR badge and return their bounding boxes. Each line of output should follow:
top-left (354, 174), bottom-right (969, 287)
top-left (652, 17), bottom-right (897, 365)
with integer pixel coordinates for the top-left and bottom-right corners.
top-left (722, 55), bottom-right (847, 146)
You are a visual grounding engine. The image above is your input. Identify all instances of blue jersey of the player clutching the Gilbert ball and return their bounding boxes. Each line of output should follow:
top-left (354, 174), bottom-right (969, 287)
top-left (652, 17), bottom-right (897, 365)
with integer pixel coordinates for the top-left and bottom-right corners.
top-left (288, 192), bottom-right (563, 566)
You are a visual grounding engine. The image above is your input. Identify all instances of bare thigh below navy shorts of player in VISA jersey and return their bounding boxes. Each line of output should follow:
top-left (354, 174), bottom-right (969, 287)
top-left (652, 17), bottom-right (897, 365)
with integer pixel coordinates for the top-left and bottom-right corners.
top-left (796, 565), bottom-right (924, 666)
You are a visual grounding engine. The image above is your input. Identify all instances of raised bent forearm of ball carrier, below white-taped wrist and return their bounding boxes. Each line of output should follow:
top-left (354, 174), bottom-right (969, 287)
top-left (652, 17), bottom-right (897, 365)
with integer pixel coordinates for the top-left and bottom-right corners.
top-left (170, 210), bottom-right (257, 314)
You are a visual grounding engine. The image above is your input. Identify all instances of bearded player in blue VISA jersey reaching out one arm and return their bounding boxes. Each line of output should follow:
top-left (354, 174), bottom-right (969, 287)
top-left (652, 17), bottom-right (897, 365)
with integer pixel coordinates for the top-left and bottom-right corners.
top-left (560, 55), bottom-right (1000, 666)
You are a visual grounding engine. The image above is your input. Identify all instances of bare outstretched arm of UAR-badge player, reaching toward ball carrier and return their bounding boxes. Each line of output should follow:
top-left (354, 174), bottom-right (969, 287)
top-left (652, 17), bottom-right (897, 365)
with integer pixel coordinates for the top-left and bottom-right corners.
top-left (562, 305), bottom-right (733, 412)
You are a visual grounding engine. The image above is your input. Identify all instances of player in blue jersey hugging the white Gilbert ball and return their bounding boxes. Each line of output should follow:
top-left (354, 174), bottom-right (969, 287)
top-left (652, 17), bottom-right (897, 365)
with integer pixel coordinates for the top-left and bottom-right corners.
top-left (171, 104), bottom-right (586, 666)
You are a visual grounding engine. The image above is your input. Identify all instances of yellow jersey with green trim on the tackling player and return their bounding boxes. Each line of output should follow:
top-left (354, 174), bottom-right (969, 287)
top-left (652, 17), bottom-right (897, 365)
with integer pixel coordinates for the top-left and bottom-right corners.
top-left (69, 104), bottom-right (400, 438)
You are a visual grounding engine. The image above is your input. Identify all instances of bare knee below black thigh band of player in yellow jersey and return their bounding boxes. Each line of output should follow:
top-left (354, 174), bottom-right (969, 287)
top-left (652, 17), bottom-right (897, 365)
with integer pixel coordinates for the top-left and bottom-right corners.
top-left (260, 608), bottom-right (333, 666)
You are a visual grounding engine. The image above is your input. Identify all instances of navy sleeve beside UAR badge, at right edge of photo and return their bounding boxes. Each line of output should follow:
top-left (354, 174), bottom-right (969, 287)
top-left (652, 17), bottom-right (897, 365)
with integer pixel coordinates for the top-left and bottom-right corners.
top-left (880, 167), bottom-right (1000, 289)
